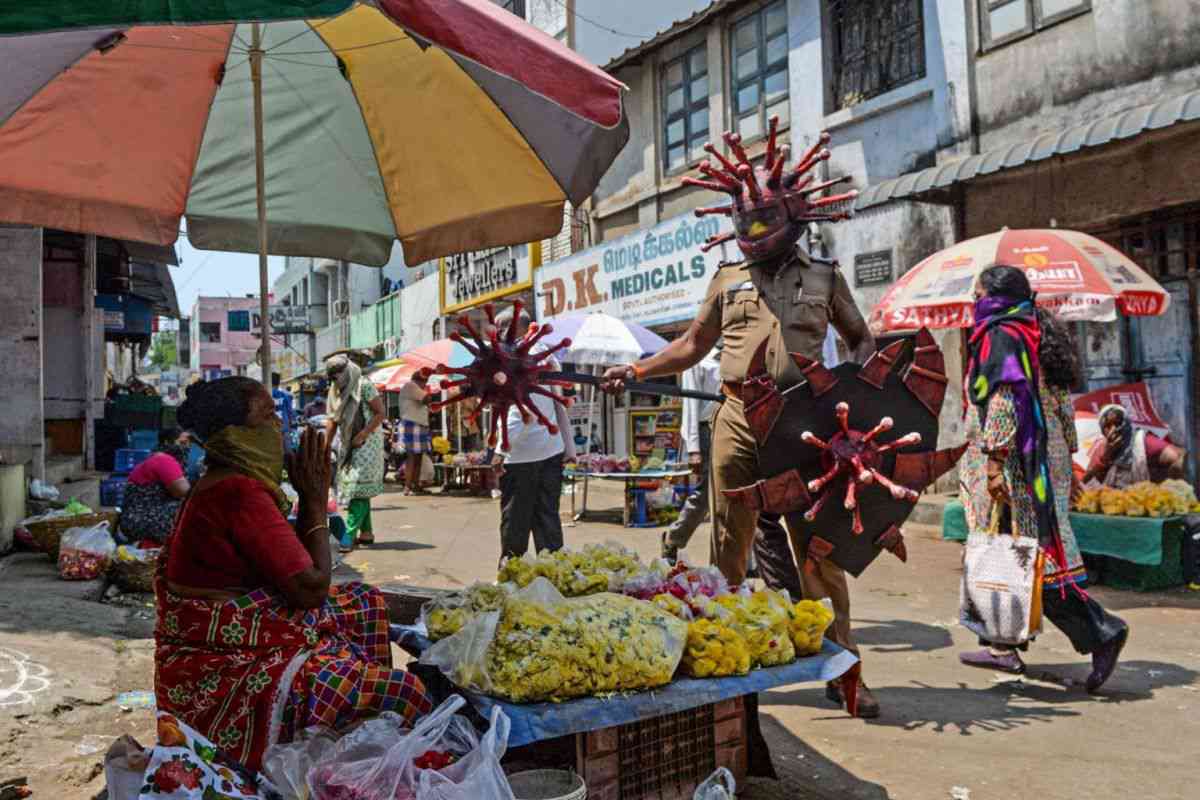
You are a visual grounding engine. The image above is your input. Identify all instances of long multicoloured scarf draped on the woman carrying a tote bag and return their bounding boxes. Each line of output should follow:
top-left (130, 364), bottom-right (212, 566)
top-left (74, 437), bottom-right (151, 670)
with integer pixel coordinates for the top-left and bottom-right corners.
top-left (967, 295), bottom-right (1067, 585)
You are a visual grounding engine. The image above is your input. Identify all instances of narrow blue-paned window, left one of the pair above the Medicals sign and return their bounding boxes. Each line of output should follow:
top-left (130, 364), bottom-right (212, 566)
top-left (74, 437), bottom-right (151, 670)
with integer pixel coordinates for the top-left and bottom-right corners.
top-left (662, 44), bottom-right (708, 170)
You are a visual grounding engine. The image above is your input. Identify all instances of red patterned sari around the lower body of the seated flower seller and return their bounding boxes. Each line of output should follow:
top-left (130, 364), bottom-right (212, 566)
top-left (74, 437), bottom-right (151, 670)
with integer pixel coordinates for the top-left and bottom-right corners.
top-left (155, 535), bottom-right (431, 770)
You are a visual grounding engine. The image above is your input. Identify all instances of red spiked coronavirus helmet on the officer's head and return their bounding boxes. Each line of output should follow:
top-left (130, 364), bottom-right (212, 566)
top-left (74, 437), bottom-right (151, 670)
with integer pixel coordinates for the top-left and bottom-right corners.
top-left (683, 116), bottom-right (858, 261)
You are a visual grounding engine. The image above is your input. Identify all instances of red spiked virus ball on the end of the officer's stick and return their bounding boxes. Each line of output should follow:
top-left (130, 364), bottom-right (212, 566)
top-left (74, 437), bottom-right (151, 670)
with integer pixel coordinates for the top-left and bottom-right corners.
top-left (422, 302), bottom-right (571, 450)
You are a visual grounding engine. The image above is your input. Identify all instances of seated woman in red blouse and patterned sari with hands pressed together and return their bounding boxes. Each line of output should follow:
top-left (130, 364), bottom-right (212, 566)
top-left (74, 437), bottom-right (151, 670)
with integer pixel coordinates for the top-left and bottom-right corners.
top-left (155, 378), bottom-right (431, 769)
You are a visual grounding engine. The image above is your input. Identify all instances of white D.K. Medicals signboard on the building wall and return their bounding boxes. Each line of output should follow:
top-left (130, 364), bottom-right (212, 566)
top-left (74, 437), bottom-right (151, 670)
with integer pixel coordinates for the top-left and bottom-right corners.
top-left (534, 212), bottom-right (740, 326)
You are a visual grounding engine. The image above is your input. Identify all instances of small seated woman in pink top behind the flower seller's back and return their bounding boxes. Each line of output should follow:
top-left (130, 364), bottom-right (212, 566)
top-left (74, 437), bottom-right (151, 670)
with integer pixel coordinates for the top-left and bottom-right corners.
top-left (121, 428), bottom-right (191, 542)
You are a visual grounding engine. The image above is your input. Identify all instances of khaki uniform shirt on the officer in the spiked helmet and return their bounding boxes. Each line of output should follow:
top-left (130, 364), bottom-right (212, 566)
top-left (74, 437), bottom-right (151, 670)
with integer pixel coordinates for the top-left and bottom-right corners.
top-left (697, 249), bottom-right (869, 389)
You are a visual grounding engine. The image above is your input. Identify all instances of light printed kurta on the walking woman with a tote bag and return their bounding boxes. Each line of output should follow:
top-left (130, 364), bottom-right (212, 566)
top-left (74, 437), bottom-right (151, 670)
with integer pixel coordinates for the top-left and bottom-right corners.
top-left (959, 384), bottom-right (1087, 588)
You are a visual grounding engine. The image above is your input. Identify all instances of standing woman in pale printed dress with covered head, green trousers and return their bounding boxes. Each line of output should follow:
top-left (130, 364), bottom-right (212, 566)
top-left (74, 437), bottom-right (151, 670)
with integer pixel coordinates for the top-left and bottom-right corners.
top-left (325, 355), bottom-right (385, 551)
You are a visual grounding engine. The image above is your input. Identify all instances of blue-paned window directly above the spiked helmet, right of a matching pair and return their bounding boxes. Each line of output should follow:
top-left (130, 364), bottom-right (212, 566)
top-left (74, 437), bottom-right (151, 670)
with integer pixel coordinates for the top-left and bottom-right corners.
top-left (730, 0), bottom-right (791, 139)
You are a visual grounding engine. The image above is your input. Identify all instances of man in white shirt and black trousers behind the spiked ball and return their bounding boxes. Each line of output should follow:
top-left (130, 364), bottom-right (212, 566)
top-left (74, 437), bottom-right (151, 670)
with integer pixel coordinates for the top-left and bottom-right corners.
top-left (485, 308), bottom-right (575, 559)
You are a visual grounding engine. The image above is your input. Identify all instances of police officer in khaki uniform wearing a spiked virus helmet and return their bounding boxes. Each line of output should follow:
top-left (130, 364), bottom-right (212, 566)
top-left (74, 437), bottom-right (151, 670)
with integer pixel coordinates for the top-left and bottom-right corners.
top-left (605, 123), bottom-right (878, 716)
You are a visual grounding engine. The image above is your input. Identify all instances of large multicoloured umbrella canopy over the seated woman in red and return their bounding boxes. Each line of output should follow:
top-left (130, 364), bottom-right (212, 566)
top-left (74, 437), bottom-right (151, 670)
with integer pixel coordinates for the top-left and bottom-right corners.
top-left (0, 0), bottom-right (629, 264)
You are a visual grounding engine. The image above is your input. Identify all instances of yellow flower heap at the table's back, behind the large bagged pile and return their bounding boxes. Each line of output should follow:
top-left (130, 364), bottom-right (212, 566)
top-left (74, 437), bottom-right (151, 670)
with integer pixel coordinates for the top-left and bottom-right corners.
top-left (497, 545), bottom-right (642, 597)
